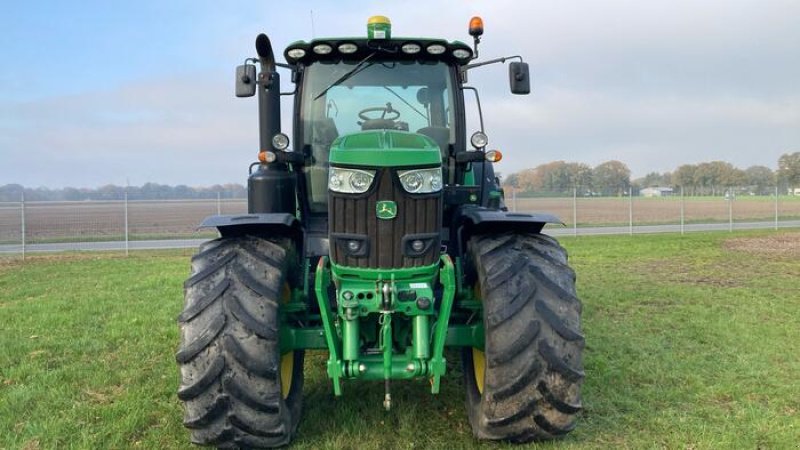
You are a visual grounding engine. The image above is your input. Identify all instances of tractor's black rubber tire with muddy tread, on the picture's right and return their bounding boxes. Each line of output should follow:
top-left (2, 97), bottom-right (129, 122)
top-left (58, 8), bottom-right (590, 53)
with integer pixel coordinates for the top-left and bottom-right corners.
top-left (462, 233), bottom-right (584, 442)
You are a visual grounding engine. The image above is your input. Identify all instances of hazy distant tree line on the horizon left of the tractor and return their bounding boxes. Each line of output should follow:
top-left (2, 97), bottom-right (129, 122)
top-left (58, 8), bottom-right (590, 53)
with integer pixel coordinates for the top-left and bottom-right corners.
top-left (0, 183), bottom-right (247, 202)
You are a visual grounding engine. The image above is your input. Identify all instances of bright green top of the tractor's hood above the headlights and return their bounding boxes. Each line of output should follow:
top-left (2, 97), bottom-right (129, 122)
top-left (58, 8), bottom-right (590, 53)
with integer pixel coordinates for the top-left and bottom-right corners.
top-left (330, 130), bottom-right (442, 167)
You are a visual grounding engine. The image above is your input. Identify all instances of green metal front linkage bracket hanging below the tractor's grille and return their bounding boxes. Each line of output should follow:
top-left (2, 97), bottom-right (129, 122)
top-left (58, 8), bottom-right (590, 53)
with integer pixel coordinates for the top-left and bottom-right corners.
top-left (314, 255), bottom-right (456, 398)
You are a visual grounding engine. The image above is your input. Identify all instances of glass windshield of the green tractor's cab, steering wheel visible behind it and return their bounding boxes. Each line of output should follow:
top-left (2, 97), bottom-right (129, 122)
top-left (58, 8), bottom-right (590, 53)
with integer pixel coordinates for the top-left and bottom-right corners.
top-left (299, 58), bottom-right (455, 212)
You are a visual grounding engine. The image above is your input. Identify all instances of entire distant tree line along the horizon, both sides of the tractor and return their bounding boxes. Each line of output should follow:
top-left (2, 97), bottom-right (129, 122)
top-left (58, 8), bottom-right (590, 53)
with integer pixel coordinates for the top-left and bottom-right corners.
top-left (0, 152), bottom-right (800, 202)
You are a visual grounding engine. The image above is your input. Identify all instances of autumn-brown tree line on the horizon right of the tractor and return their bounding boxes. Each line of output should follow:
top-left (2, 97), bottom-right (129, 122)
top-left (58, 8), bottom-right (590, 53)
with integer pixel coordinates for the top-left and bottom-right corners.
top-left (503, 152), bottom-right (800, 196)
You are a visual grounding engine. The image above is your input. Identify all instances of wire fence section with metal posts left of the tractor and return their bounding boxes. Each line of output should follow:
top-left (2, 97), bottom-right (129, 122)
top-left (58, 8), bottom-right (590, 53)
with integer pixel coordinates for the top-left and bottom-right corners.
top-left (0, 197), bottom-right (247, 258)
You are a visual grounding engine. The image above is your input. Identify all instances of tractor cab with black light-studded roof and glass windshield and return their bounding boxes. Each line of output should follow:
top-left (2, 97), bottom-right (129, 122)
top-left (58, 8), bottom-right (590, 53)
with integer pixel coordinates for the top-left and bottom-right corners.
top-left (285, 38), bottom-right (472, 213)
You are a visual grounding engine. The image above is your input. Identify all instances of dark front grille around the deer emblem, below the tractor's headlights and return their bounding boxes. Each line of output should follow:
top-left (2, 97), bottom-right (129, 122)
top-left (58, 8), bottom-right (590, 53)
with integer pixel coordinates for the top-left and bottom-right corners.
top-left (328, 169), bottom-right (442, 269)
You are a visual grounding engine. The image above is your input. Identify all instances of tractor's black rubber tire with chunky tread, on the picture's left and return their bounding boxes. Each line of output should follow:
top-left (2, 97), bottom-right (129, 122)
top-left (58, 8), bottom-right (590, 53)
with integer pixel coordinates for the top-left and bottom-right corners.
top-left (175, 236), bottom-right (304, 448)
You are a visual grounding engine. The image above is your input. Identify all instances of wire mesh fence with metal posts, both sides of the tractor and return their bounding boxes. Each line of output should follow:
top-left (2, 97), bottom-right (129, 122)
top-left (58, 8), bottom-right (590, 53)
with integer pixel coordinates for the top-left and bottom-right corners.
top-left (0, 189), bottom-right (800, 258)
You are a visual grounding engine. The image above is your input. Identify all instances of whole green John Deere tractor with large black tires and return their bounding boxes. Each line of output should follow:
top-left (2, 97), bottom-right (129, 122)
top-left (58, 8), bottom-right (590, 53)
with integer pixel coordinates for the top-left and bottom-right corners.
top-left (176, 16), bottom-right (584, 448)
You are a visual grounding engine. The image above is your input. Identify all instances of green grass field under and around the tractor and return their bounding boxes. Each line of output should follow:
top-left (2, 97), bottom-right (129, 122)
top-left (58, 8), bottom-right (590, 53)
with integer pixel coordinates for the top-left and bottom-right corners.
top-left (0, 231), bottom-right (800, 449)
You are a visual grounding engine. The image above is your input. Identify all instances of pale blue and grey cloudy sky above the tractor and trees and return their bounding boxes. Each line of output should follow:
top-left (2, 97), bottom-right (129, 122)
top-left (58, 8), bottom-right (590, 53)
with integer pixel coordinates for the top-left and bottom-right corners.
top-left (0, 0), bottom-right (800, 187)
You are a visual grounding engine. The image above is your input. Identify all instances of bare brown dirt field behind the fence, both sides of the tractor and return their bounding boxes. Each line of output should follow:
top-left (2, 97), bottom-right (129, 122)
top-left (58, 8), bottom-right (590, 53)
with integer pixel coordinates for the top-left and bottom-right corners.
top-left (0, 197), bottom-right (800, 243)
